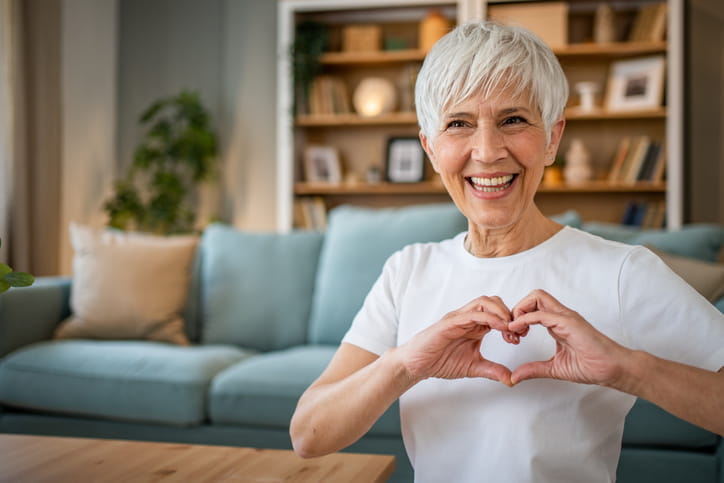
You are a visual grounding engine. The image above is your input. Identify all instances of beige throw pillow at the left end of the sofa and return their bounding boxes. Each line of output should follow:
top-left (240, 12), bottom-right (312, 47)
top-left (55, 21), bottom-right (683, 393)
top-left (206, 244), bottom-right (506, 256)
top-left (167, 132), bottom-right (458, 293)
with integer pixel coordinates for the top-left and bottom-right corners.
top-left (55, 224), bottom-right (198, 345)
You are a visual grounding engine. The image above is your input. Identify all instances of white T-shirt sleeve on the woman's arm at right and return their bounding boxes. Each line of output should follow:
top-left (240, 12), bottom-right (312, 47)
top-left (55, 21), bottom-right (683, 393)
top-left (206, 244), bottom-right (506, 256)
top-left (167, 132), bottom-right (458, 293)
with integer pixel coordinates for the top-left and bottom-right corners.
top-left (618, 247), bottom-right (724, 371)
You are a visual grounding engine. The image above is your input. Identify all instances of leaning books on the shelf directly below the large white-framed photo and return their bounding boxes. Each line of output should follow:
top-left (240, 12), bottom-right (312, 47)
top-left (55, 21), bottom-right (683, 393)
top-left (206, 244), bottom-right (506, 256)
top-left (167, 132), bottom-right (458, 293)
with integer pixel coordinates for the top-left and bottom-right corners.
top-left (608, 136), bottom-right (666, 184)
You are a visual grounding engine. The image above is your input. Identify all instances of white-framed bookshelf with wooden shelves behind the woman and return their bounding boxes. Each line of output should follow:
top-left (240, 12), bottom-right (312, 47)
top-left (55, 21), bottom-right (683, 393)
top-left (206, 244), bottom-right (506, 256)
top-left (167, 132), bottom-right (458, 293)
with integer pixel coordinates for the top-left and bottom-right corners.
top-left (278, 0), bottom-right (682, 229)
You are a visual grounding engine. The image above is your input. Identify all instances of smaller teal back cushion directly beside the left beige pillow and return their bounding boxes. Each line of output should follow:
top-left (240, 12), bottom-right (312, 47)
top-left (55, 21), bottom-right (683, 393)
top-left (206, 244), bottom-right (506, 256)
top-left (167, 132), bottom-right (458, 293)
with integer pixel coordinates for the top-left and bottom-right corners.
top-left (201, 224), bottom-right (322, 351)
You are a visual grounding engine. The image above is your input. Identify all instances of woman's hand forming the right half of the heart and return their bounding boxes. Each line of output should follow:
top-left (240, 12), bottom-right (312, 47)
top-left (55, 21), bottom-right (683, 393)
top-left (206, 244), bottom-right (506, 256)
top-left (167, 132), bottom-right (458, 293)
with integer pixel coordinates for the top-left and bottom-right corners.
top-left (508, 290), bottom-right (629, 386)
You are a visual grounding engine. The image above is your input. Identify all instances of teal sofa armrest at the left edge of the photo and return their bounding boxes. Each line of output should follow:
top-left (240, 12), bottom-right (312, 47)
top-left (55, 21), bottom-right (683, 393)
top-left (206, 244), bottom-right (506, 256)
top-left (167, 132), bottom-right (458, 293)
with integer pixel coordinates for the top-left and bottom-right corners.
top-left (0, 277), bottom-right (71, 357)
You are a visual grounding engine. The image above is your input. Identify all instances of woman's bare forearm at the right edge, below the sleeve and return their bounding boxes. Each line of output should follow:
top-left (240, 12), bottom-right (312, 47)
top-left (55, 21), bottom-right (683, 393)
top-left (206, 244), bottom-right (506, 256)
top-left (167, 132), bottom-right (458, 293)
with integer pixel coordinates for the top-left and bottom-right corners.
top-left (614, 351), bottom-right (724, 435)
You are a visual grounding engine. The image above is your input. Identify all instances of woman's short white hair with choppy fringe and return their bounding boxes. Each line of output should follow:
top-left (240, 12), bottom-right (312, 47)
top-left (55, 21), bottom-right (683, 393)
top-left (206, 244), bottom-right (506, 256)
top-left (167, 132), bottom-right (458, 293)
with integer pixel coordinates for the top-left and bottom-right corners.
top-left (415, 22), bottom-right (568, 140)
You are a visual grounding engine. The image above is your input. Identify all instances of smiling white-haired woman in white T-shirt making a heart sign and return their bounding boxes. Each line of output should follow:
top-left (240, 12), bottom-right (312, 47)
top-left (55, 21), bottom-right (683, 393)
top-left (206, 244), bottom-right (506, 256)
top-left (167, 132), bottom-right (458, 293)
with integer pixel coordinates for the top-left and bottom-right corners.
top-left (291, 23), bottom-right (724, 482)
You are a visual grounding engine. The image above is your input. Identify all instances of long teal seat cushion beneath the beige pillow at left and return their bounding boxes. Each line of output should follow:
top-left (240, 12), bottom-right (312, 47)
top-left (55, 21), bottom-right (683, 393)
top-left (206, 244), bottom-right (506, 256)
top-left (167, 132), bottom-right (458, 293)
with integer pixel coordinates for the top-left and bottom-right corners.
top-left (0, 340), bottom-right (250, 425)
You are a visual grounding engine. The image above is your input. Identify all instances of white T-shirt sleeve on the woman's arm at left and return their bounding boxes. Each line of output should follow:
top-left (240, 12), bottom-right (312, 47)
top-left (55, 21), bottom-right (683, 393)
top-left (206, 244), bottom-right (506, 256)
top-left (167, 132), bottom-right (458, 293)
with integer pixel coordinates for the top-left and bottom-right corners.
top-left (342, 252), bottom-right (400, 355)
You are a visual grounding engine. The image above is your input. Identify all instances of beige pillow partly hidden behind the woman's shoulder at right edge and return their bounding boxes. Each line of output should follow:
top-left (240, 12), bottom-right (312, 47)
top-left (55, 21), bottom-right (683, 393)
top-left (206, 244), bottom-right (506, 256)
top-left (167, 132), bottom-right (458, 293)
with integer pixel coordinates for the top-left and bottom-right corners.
top-left (647, 246), bottom-right (724, 302)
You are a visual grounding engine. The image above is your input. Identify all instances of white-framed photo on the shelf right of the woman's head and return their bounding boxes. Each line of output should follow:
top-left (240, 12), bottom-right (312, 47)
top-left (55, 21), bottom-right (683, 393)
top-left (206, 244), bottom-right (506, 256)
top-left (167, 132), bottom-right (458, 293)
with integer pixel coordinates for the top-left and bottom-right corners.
top-left (606, 55), bottom-right (666, 111)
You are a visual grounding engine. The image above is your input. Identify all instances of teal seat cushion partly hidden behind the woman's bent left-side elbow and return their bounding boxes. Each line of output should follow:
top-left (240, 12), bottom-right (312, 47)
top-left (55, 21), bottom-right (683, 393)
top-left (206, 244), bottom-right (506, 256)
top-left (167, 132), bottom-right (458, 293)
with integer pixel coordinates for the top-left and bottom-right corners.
top-left (209, 345), bottom-right (400, 435)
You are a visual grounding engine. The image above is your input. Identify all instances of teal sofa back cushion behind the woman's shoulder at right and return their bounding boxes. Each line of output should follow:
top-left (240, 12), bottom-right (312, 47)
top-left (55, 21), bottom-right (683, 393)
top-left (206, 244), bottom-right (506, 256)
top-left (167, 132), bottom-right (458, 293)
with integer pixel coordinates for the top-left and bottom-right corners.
top-left (582, 223), bottom-right (724, 262)
